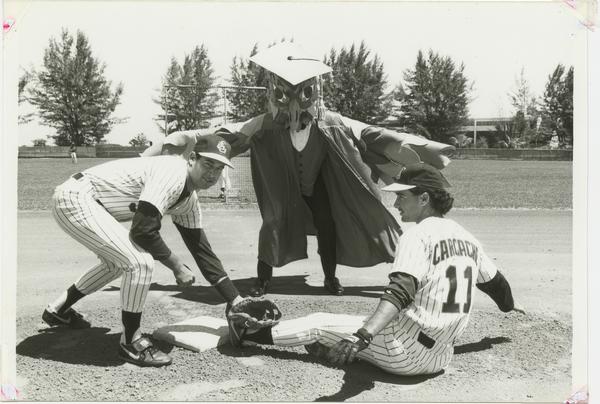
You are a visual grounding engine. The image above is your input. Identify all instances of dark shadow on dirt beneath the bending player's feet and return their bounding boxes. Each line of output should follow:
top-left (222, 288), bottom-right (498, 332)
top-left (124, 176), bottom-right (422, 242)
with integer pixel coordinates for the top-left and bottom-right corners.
top-left (16, 327), bottom-right (125, 367)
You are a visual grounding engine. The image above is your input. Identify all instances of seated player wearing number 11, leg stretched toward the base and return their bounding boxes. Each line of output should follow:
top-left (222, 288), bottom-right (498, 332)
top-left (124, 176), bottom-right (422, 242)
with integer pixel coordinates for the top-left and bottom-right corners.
top-left (230, 163), bottom-right (524, 375)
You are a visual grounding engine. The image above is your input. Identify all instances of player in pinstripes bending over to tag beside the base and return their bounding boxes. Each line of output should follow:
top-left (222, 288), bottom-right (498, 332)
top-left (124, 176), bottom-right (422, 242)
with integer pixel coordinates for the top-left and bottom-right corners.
top-left (42, 135), bottom-right (252, 366)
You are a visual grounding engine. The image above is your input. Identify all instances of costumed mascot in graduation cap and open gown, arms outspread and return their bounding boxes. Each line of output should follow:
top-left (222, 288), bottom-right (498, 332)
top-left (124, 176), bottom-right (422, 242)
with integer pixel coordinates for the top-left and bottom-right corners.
top-left (143, 42), bottom-right (454, 296)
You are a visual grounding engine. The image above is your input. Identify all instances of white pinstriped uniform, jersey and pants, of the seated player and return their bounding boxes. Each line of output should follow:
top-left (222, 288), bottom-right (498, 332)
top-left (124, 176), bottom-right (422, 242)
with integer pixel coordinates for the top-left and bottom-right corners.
top-left (272, 217), bottom-right (497, 375)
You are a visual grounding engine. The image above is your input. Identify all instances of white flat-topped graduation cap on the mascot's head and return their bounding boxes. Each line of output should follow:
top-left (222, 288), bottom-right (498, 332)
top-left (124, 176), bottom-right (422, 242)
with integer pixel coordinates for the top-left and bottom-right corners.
top-left (250, 42), bottom-right (332, 86)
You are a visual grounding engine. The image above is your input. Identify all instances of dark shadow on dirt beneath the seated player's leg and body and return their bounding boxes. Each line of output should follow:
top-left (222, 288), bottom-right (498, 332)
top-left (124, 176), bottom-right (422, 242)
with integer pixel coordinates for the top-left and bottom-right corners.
top-left (217, 344), bottom-right (444, 402)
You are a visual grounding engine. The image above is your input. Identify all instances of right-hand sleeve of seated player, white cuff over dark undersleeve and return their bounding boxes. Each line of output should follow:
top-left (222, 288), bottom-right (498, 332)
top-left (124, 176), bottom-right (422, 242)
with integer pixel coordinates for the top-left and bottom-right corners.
top-left (476, 251), bottom-right (515, 312)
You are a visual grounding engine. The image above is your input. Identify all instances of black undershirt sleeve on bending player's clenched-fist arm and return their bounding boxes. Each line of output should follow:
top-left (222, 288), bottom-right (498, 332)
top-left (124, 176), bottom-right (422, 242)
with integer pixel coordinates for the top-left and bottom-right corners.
top-left (129, 201), bottom-right (171, 261)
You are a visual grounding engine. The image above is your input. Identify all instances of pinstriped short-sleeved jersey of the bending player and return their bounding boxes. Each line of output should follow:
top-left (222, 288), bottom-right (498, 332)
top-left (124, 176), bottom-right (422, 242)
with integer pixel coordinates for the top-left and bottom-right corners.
top-left (83, 156), bottom-right (202, 228)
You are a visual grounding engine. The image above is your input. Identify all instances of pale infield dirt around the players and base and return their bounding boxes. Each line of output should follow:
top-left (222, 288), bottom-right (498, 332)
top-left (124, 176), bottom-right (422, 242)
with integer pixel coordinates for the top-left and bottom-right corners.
top-left (16, 210), bottom-right (572, 402)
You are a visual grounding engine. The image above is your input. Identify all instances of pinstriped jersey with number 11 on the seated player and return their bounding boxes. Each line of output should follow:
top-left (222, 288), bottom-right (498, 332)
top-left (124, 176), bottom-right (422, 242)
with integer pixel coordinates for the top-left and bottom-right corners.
top-left (392, 217), bottom-right (497, 345)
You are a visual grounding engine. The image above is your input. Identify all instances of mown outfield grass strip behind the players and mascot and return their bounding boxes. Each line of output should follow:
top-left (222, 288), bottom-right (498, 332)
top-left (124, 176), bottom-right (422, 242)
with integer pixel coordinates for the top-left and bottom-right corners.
top-left (18, 158), bottom-right (573, 210)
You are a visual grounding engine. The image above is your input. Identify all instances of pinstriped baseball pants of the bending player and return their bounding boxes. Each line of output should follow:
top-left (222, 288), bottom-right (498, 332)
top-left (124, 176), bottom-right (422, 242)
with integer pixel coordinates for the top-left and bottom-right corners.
top-left (52, 177), bottom-right (154, 313)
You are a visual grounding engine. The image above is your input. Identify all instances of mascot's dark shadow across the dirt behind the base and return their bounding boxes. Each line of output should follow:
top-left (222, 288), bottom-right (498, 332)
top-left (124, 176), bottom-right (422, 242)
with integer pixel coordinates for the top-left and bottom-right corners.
top-left (103, 275), bottom-right (383, 305)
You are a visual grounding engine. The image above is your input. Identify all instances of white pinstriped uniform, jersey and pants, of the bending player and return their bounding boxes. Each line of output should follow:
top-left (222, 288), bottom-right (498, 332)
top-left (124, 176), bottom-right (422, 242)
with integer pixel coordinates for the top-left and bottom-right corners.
top-left (53, 156), bottom-right (202, 313)
